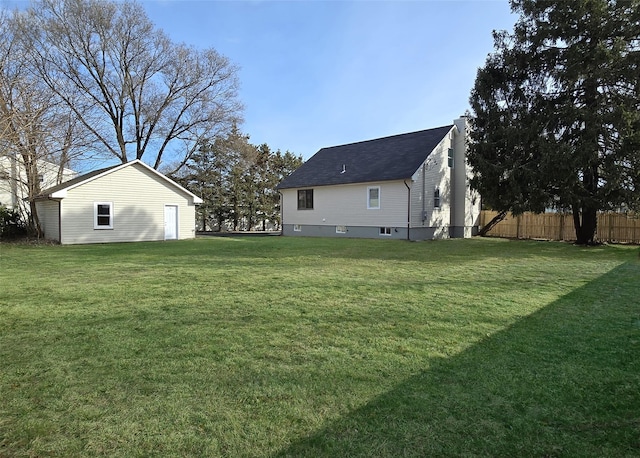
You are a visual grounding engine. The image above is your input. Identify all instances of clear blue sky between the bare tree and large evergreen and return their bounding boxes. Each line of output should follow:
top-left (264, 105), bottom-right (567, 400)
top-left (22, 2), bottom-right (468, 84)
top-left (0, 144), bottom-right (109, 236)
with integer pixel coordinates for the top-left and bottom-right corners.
top-left (141, 0), bottom-right (516, 159)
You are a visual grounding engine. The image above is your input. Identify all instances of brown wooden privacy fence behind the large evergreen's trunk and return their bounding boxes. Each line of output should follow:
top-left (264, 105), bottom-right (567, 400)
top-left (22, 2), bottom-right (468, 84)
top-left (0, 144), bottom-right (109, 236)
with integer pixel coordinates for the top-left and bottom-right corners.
top-left (480, 210), bottom-right (640, 244)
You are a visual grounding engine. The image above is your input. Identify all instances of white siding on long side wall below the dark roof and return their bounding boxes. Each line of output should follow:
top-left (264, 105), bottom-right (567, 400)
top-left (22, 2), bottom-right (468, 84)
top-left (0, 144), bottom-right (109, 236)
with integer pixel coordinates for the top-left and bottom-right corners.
top-left (282, 181), bottom-right (408, 227)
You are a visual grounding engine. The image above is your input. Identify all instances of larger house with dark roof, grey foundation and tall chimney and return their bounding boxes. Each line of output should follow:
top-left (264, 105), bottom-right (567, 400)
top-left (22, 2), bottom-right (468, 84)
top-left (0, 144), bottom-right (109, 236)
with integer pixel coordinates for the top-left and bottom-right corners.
top-left (278, 117), bottom-right (480, 240)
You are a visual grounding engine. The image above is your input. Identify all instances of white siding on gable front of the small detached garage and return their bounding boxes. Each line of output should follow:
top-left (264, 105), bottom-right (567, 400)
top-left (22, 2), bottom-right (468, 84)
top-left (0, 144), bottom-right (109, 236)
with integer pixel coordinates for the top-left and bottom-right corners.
top-left (61, 164), bottom-right (195, 243)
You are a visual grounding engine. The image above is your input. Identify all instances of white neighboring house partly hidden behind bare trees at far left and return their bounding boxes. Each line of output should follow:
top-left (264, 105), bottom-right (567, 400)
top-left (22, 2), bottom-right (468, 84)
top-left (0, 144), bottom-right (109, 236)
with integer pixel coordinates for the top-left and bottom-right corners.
top-left (0, 155), bottom-right (77, 215)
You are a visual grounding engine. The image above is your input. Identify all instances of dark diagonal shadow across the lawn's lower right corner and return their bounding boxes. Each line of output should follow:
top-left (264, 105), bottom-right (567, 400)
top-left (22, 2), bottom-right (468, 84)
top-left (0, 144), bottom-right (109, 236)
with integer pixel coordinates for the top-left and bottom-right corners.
top-left (274, 261), bottom-right (640, 457)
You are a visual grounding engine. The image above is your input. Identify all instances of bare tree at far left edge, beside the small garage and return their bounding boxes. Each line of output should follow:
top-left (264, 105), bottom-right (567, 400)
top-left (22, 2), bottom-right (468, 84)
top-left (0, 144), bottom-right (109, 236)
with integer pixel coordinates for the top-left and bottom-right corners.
top-left (0, 11), bottom-right (84, 235)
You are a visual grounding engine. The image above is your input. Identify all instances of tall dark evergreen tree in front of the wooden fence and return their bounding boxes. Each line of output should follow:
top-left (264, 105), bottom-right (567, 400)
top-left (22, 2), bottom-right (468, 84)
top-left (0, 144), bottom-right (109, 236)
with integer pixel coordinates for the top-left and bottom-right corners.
top-left (469, 0), bottom-right (640, 244)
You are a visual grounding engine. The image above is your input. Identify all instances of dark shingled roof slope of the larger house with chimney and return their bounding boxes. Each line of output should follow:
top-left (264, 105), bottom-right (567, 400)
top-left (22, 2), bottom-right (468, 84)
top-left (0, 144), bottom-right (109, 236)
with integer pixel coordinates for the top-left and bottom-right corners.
top-left (278, 125), bottom-right (453, 189)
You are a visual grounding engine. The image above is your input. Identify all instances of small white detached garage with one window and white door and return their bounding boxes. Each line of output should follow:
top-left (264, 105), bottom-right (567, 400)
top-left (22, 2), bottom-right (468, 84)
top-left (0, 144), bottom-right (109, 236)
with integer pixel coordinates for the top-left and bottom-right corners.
top-left (36, 160), bottom-right (202, 244)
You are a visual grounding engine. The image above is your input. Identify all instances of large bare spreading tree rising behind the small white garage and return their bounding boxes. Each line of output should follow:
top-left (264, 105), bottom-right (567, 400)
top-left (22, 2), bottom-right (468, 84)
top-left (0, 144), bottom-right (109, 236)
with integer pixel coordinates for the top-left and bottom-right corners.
top-left (20, 0), bottom-right (242, 172)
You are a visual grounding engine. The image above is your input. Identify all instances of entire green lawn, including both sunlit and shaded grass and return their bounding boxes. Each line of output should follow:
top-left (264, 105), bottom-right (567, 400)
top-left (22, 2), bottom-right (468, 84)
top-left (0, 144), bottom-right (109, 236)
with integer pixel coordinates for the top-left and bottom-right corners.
top-left (0, 237), bottom-right (640, 457)
